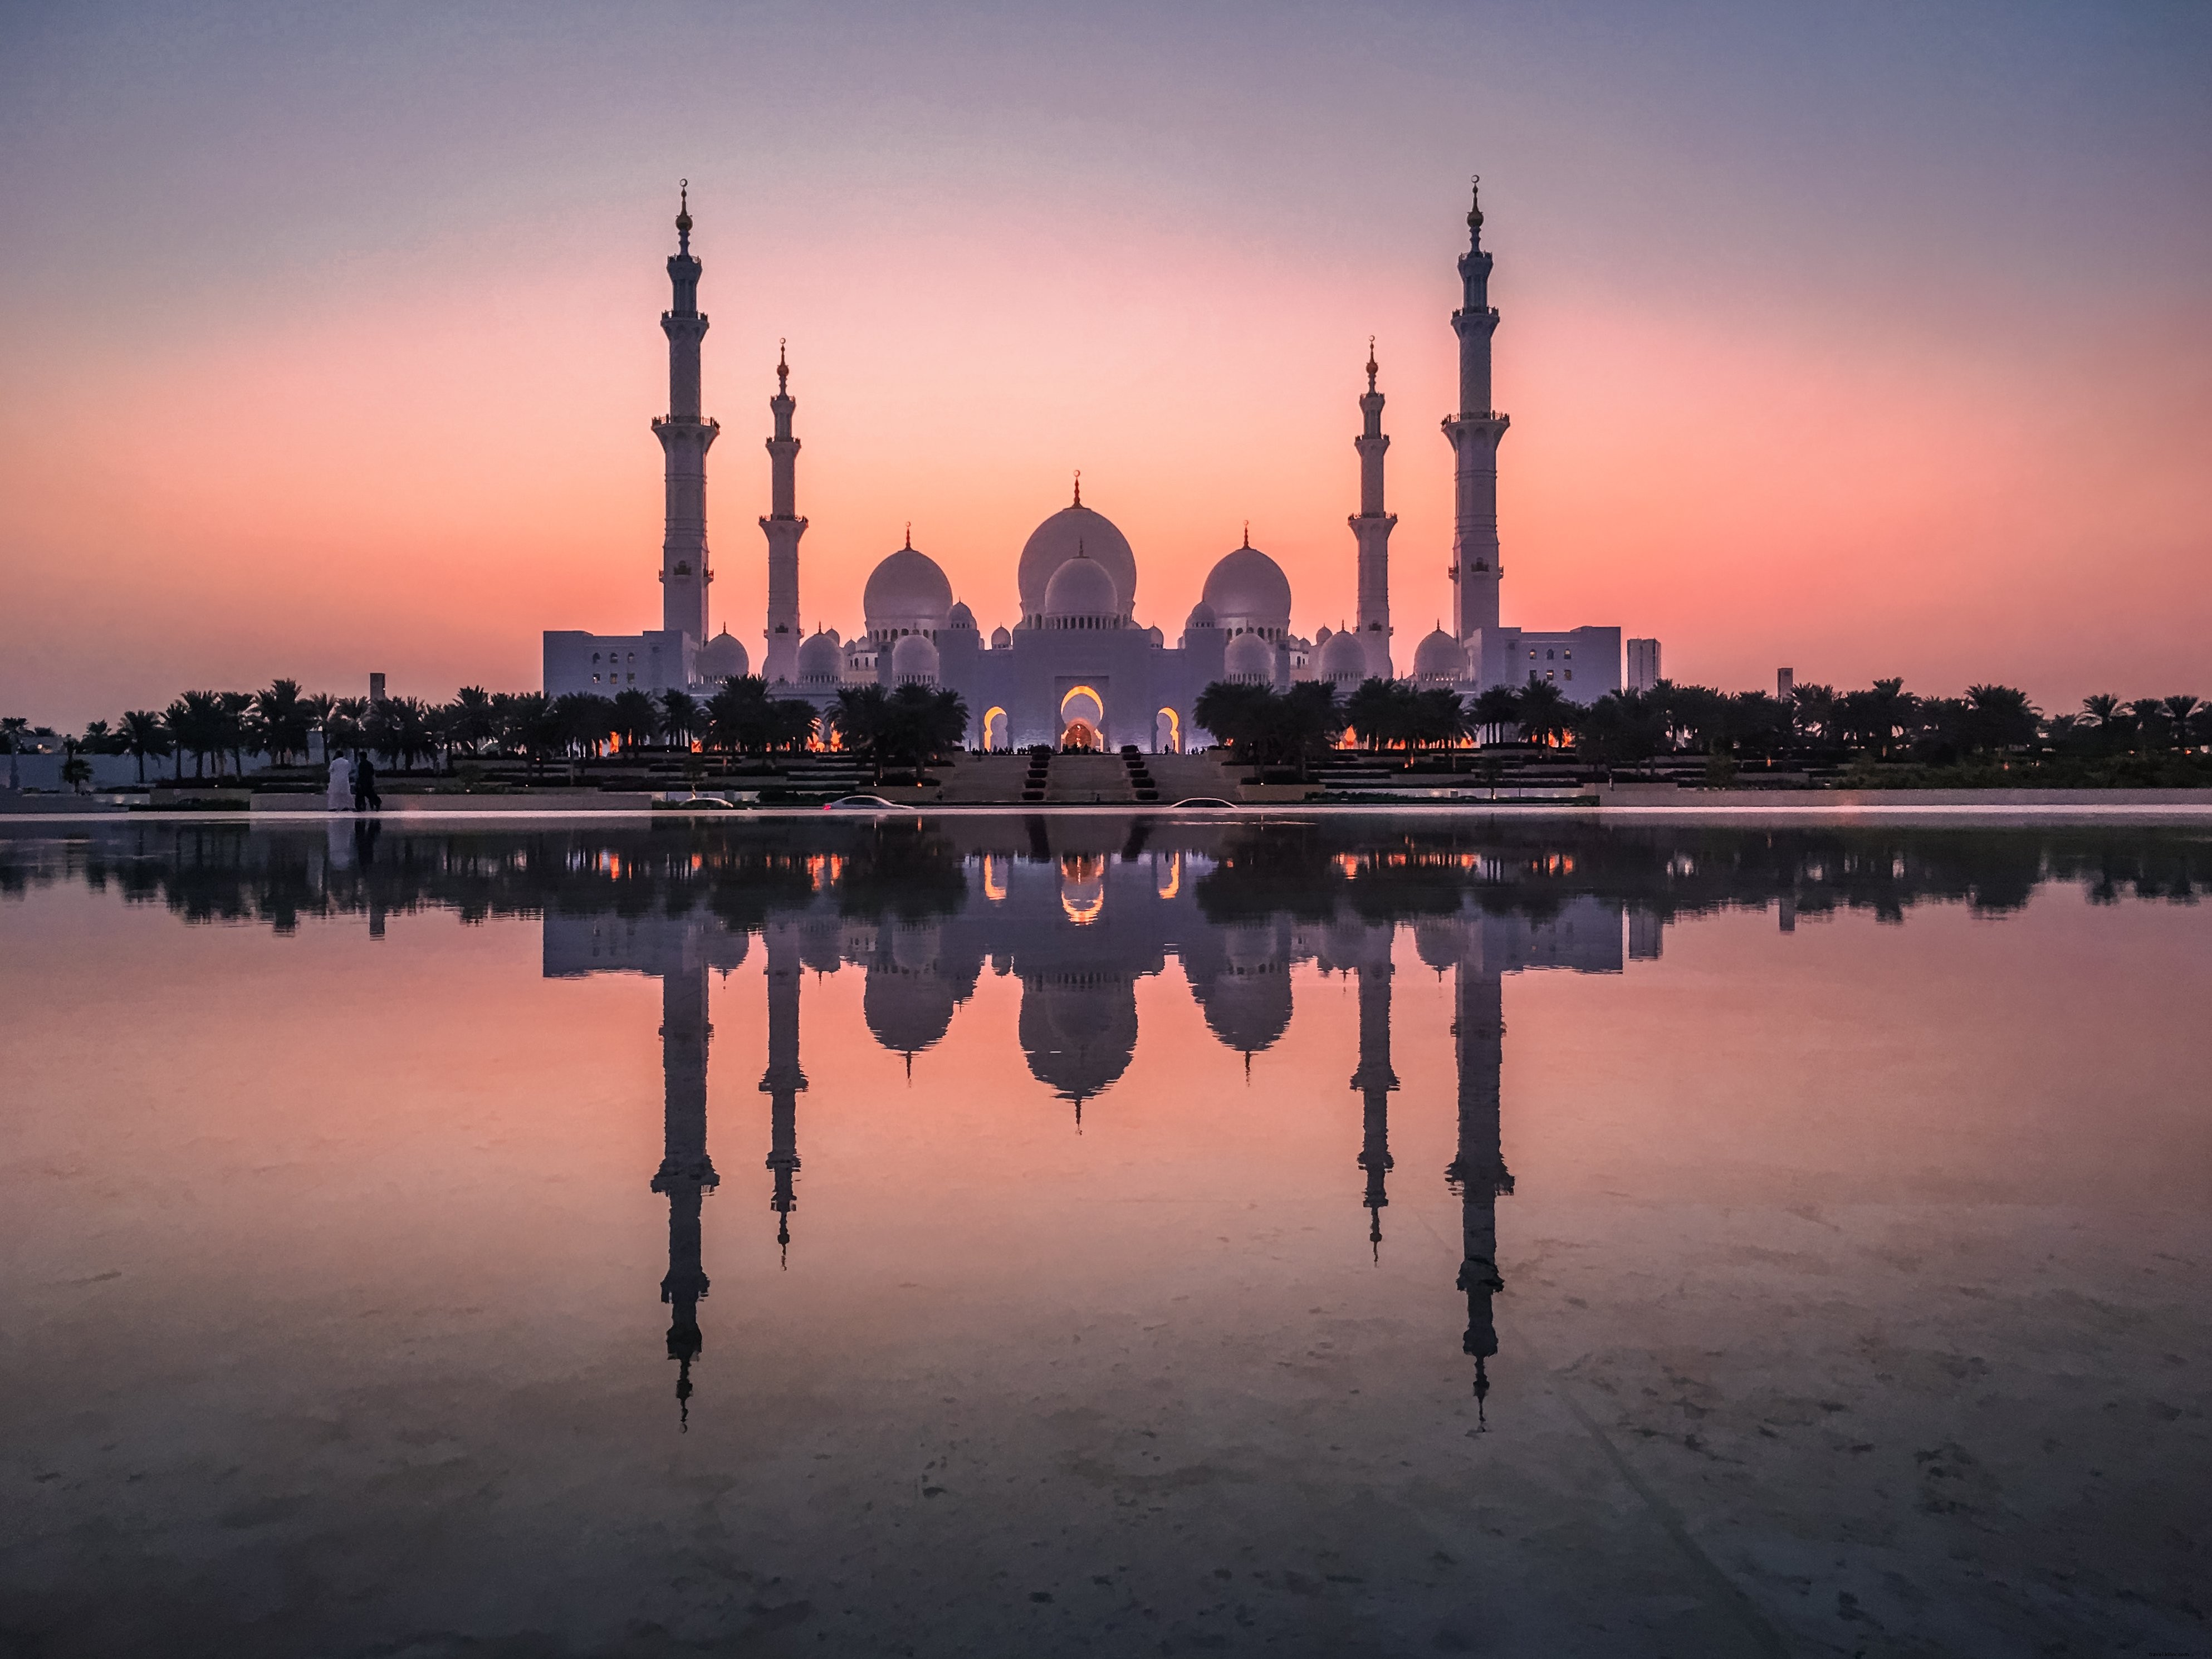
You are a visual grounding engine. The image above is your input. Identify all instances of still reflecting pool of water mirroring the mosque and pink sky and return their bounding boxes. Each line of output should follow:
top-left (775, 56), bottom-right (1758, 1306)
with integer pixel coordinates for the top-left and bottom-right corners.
top-left (0, 814), bottom-right (2212, 1657)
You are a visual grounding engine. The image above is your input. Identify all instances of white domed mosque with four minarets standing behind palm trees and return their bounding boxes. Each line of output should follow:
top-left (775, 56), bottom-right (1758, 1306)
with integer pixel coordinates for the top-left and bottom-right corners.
top-left (544, 190), bottom-right (1659, 752)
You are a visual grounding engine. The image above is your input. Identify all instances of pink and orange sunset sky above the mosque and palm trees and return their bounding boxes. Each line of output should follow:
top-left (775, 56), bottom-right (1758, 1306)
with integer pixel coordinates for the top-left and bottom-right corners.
top-left (0, 0), bottom-right (2212, 728)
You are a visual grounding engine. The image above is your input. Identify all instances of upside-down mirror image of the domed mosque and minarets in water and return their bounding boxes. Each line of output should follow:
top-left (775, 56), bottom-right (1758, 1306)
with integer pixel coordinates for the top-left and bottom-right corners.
top-left (544, 849), bottom-right (1623, 1416)
